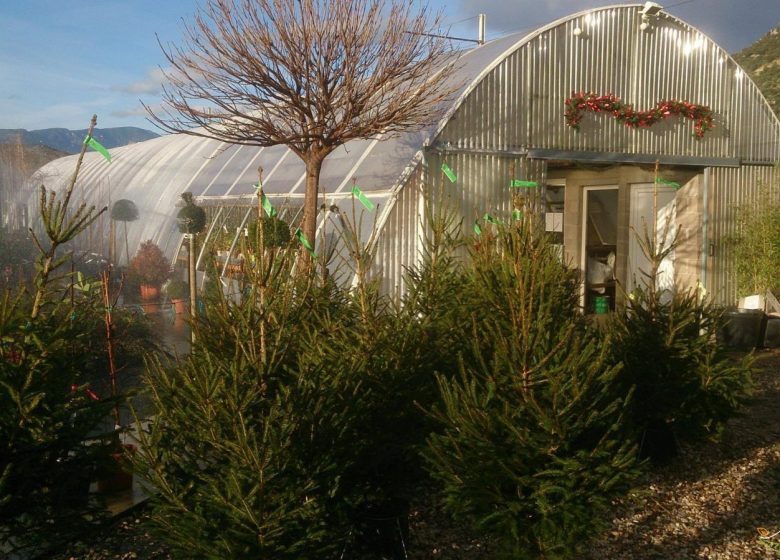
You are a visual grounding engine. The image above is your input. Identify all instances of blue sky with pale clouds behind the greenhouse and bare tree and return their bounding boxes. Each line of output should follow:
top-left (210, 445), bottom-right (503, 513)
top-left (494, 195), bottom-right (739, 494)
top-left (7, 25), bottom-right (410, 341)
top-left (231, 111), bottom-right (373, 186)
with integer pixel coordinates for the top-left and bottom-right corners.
top-left (0, 0), bottom-right (780, 132)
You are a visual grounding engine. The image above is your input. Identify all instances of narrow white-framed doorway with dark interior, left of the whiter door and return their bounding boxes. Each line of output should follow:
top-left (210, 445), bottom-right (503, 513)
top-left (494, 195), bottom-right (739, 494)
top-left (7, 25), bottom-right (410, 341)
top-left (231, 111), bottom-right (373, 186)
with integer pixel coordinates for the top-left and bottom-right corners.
top-left (580, 186), bottom-right (618, 313)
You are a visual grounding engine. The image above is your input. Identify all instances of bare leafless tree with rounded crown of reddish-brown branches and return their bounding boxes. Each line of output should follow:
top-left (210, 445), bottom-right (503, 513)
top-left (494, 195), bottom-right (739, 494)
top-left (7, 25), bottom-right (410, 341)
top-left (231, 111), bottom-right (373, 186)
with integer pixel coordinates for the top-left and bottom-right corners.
top-left (147, 0), bottom-right (452, 259)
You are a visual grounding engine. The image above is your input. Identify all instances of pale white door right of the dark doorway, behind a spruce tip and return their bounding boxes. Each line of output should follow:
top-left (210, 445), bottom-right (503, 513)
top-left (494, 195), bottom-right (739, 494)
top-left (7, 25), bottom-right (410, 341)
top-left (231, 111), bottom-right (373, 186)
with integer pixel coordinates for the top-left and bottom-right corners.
top-left (626, 183), bottom-right (677, 298)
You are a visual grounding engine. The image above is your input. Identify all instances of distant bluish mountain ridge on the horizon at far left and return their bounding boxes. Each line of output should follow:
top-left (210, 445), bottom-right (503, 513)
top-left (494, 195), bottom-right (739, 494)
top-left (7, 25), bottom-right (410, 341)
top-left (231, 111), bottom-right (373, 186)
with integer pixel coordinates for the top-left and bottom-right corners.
top-left (0, 126), bottom-right (159, 154)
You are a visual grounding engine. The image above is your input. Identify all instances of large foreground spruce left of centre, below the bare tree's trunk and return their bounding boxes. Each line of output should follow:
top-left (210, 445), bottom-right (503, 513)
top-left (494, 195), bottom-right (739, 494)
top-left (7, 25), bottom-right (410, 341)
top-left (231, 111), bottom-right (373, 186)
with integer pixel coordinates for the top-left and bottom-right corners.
top-left (136, 238), bottom-right (360, 559)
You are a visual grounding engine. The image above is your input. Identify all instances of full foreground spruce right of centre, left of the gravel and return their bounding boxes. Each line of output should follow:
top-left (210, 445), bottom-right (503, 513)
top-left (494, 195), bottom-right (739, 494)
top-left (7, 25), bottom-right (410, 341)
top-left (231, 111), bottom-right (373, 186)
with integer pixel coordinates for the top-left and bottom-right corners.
top-left (424, 222), bottom-right (635, 558)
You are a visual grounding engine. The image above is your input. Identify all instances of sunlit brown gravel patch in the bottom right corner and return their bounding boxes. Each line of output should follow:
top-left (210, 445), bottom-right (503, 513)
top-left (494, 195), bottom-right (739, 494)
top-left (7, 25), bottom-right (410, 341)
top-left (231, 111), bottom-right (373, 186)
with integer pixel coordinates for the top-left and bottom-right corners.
top-left (584, 352), bottom-right (780, 560)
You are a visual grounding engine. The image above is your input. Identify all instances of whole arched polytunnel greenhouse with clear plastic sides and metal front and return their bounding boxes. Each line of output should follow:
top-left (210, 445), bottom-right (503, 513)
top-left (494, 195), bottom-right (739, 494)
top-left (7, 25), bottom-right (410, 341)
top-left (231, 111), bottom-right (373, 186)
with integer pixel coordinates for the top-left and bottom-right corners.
top-left (29, 3), bottom-right (780, 304)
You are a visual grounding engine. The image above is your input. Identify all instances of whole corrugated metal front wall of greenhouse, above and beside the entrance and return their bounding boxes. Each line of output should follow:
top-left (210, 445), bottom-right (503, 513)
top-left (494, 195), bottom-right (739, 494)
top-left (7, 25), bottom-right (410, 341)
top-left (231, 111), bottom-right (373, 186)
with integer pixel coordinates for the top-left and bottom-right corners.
top-left (377, 5), bottom-right (780, 302)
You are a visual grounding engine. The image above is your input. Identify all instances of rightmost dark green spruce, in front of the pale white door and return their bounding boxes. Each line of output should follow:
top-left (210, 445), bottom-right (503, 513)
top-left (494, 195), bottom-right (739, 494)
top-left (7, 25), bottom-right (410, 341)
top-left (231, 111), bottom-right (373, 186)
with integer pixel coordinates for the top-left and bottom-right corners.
top-left (605, 212), bottom-right (751, 462)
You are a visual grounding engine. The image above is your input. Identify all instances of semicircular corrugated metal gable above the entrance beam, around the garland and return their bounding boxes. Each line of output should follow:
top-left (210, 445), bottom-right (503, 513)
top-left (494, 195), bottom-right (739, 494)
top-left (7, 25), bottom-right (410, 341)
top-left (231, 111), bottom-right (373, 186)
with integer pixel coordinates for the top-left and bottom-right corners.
top-left (436, 6), bottom-right (780, 162)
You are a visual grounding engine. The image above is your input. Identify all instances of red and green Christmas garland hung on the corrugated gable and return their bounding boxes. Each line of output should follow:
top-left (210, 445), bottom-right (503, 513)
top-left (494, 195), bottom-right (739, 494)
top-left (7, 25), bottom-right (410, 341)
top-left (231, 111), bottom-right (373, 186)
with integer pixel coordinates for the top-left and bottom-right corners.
top-left (564, 92), bottom-right (715, 138)
